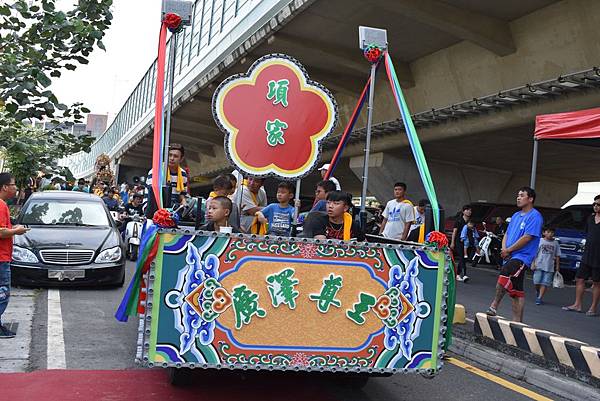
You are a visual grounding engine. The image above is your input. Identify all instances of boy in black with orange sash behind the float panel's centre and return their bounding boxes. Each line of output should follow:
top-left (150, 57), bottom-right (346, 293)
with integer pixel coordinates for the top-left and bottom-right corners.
top-left (303, 191), bottom-right (365, 241)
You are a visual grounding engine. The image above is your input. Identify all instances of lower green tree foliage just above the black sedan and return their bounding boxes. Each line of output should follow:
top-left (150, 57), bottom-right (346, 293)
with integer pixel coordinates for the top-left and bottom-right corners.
top-left (0, 111), bottom-right (94, 187)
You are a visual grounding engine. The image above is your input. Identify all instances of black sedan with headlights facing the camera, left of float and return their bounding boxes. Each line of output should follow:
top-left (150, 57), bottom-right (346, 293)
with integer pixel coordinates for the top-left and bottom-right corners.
top-left (11, 191), bottom-right (125, 286)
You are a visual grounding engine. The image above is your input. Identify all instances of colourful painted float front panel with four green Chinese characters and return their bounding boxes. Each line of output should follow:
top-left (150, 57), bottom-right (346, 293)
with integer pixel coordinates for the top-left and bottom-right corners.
top-left (139, 229), bottom-right (449, 374)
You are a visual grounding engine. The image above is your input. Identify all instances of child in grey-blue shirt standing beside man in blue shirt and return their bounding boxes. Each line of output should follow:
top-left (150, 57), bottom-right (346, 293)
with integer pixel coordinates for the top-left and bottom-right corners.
top-left (531, 227), bottom-right (560, 305)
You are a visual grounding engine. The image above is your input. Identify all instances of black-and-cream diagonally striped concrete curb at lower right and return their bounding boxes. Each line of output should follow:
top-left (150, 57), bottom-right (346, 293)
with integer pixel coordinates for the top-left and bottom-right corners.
top-left (474, 313), bottom-right (600, 387)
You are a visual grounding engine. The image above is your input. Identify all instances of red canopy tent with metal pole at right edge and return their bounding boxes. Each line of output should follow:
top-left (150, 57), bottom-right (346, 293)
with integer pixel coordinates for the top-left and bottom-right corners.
top-left (530, 107), bottom-right (600, 188)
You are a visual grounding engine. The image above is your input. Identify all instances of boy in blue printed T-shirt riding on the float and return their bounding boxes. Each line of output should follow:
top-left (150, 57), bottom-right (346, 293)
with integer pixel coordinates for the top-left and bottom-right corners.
top-left (255, 181), bottom-right (295, 237)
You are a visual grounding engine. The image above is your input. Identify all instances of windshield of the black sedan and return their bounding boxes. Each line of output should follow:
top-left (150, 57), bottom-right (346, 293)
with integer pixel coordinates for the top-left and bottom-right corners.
top-left (21, 199), bottom-right (110, 227)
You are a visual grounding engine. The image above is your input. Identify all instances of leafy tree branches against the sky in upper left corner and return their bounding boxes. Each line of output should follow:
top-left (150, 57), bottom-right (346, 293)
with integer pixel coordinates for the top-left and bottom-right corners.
top-left (0, 0), bottom-right (112, 122)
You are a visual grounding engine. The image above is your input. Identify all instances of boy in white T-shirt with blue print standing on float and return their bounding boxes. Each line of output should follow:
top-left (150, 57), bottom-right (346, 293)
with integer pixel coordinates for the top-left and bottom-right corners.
top-left (381, 182), bottom-right (415, 241)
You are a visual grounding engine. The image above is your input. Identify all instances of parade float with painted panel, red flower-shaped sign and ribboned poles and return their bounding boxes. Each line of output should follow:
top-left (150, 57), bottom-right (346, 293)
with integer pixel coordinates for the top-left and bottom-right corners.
top-left (116, 8), bottom-right (454, 381)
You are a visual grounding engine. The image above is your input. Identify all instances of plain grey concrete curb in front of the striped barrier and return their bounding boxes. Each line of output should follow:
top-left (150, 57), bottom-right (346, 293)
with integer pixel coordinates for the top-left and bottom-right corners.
top-left (450, 330), bottom-right (599, 401)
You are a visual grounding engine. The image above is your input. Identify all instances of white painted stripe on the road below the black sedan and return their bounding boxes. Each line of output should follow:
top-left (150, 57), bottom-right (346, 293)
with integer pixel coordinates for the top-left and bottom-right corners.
top-left (46, 289), bottom-right (67, 369)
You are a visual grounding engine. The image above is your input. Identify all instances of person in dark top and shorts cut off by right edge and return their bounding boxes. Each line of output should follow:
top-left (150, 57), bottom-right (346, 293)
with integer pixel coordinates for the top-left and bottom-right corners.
top-left (563, 195), bottom-right (600, 316)
